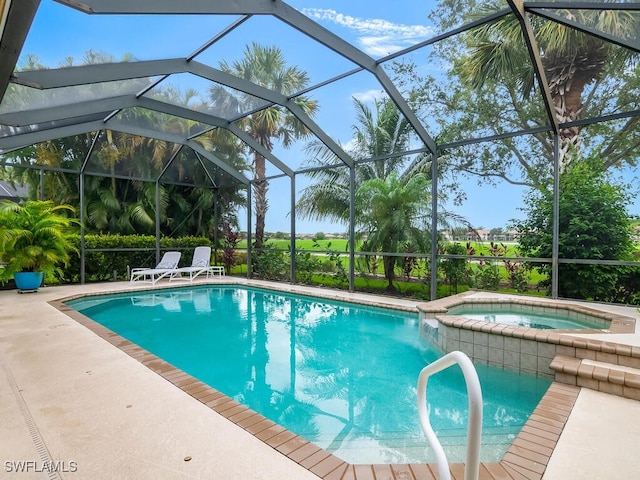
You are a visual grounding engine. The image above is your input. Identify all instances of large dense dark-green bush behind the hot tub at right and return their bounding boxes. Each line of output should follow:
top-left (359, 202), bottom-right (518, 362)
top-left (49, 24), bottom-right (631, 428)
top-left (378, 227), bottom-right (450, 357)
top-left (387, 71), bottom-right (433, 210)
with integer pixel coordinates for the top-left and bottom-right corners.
top-left (515, 159), bottom-right (638, 301)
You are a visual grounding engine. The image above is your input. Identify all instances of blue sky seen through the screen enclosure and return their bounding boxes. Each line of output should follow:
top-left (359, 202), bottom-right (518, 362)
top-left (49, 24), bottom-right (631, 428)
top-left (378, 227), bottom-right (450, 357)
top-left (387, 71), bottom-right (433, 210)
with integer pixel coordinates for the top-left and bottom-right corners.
top-left (15, 0), bottom-right (640, 233)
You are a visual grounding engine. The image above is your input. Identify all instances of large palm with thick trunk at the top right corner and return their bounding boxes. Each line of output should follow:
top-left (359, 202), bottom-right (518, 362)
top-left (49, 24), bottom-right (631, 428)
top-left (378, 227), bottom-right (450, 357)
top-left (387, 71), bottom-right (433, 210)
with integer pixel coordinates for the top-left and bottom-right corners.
top-left (460, 5), bottom-right (639, 171)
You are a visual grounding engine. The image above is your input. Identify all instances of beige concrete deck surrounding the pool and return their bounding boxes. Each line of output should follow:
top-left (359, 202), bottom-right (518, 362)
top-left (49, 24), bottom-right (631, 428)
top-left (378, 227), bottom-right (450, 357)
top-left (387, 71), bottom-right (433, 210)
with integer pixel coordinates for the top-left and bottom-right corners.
top-left (0, 278), bottom-right (640, 480)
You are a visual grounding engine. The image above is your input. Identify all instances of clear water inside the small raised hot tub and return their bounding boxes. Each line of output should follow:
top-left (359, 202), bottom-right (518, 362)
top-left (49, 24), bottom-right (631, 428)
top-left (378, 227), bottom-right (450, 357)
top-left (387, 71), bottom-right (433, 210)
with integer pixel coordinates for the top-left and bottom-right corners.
top-left (449, 305), bottom-right (603, 330)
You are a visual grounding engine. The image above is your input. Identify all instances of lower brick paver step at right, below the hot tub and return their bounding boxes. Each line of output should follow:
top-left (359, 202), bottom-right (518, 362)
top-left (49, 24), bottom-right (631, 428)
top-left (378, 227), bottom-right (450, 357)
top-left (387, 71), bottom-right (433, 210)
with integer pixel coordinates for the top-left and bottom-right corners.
top-left (550, 355), bottom-right (640, 400)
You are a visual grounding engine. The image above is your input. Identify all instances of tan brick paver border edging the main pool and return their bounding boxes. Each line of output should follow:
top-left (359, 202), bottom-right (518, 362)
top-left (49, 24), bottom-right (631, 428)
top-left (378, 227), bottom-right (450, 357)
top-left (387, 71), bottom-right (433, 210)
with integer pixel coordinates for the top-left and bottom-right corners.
top-left (49, 286), bottom-right (580, 480)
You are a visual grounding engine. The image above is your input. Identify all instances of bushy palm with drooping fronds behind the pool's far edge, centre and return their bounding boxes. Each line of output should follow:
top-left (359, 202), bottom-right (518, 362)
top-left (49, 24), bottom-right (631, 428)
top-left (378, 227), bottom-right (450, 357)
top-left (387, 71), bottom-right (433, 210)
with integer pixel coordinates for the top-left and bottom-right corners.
top-left (296, 98), bottom-right (468, 289)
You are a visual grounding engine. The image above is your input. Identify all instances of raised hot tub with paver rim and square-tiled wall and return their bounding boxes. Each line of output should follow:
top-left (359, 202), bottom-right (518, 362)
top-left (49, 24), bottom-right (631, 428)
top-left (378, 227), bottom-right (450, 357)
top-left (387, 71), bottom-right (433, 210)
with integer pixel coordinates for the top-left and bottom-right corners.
top-left (418, 292), bottom-right (635, 378)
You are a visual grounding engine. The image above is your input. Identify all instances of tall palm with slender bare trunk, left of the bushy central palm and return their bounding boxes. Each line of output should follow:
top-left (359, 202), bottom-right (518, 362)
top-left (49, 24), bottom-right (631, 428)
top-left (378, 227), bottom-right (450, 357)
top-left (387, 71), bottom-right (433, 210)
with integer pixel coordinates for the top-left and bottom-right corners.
top-left (210, 43), bottom-right (317, 248)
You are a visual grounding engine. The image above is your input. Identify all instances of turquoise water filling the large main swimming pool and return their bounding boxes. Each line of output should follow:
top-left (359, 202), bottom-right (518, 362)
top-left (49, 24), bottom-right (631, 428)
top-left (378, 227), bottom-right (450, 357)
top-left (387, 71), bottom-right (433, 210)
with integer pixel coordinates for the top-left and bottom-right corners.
top-left (68, 286), bottom-right (550, 463)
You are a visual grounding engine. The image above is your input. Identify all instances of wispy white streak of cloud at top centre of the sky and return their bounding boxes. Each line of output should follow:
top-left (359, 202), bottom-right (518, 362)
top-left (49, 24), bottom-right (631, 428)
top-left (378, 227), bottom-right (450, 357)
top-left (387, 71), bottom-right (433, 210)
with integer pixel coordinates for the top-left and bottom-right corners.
top-left (302, 8), bottom-right (434, 57)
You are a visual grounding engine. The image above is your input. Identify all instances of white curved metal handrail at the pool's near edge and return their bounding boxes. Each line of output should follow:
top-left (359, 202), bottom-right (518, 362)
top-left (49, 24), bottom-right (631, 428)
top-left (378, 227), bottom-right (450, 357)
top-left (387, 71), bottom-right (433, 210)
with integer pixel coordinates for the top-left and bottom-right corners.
top-left (418, 351), bottom-right (482, 480)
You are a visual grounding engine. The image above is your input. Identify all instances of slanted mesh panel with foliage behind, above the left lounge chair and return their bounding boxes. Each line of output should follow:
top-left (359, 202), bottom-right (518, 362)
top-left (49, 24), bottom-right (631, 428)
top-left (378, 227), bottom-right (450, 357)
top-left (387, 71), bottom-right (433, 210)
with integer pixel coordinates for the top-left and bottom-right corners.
top-left (84, 130), bottom-right (180, 181)
